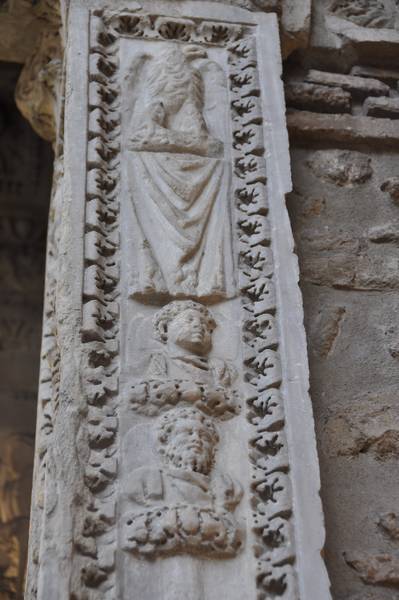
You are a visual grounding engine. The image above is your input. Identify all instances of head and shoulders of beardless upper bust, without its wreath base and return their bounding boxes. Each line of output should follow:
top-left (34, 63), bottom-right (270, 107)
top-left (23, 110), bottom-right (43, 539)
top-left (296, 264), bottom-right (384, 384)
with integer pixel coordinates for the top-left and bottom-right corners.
top-left (148, 300), bottom-right (237, 387)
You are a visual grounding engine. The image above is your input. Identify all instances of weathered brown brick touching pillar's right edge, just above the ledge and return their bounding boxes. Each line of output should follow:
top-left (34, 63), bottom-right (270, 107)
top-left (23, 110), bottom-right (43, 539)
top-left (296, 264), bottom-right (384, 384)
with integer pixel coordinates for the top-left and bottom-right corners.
top-left (285, 82), bottom-right (351, 113)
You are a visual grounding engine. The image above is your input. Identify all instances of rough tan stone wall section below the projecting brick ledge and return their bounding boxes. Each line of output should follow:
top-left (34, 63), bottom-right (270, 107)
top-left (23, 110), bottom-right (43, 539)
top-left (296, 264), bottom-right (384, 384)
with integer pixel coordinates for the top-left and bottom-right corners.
top-left (289, 147), bottom-right (399, 600)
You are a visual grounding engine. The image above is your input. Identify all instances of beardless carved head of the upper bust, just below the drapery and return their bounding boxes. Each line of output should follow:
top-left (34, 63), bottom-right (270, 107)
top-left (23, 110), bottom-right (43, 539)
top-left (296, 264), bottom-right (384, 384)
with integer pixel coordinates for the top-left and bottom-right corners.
top-left (153, 300), bottom-right (216, 356)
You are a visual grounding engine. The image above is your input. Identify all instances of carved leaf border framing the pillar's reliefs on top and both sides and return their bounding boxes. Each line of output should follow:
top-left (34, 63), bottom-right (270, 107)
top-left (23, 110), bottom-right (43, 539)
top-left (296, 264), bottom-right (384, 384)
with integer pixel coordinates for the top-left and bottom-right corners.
top-left (79, 11), bottom-right (297, 600)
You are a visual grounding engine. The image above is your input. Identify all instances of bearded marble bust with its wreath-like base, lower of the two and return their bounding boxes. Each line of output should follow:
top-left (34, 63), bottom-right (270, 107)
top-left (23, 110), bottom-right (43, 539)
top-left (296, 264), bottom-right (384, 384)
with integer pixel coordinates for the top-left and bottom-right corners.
top-left (122, 406), bottom-right (242, 558)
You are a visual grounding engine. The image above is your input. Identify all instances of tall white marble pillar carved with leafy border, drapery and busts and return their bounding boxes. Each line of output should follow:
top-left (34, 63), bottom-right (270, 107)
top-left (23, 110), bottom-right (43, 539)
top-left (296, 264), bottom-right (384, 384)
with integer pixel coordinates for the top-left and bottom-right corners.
top-left (26, 0), bottom-right (330, 600)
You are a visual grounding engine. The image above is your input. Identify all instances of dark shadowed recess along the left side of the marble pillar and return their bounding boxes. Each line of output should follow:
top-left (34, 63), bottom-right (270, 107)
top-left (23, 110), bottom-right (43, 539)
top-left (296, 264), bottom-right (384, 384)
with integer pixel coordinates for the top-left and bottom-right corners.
top-left (0, 63), bottom-right (52, 600)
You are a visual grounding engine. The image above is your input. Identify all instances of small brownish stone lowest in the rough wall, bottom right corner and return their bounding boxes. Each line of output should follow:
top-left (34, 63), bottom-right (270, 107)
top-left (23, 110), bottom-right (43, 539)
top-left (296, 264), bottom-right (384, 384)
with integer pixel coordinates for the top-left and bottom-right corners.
top-left (345, 552), bottom-right (399, 588)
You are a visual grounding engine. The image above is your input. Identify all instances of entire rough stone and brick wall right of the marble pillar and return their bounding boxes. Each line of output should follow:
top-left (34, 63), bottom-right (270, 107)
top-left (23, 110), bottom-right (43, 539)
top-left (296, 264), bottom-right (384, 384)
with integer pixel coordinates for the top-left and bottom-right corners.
top-left (285, 0), bottom-right (399, 588)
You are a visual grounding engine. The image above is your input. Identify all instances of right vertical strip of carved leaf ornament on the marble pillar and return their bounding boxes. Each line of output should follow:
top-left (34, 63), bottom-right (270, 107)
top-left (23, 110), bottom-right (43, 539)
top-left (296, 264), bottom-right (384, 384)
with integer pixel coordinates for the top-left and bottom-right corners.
top-left (229, 37), bottom-right (296, 599)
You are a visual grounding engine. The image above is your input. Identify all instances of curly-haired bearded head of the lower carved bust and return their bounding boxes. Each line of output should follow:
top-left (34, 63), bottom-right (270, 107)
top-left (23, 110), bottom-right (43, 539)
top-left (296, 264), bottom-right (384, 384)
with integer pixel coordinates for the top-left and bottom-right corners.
top-left (158, 407), bottom-right (219, 475)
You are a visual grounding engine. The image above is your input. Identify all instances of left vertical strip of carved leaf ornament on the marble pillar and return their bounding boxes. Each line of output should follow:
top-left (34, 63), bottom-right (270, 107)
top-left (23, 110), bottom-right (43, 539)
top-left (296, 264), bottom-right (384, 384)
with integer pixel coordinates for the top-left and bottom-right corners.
top-left (75, 12), bottom-right (120, 597)
